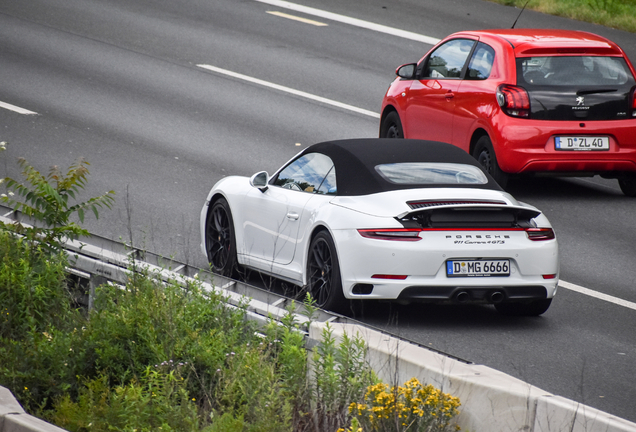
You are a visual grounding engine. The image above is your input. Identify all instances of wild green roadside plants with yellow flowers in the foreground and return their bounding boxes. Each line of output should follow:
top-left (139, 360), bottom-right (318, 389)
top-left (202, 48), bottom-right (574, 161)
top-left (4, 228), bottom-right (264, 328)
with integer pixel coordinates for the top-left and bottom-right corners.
top-left (0, 145), bottom-right (459, 432)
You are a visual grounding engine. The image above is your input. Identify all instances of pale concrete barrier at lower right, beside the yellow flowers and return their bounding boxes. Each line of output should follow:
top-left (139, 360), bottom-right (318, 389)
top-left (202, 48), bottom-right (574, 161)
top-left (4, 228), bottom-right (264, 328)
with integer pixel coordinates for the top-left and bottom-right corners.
top-left (309, 322), bottom-right (636, 432)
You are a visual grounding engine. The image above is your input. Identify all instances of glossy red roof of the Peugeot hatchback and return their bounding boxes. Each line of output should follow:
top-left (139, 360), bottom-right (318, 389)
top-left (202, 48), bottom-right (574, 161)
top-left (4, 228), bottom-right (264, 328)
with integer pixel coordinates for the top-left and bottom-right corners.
top-left (451, 29), bottom-right (623, 55)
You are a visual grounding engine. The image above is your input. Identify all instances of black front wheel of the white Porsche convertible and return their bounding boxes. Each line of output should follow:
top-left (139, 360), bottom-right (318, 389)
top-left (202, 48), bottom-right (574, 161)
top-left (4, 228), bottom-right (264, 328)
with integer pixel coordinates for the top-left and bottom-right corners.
top-left (205, 198), bottom-right (238, 277)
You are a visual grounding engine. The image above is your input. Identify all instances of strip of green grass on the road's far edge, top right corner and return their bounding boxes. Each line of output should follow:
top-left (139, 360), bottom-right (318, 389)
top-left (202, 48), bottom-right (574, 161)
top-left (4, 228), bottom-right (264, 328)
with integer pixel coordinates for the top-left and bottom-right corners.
top-left (490, 0), bottom-right (636, 33)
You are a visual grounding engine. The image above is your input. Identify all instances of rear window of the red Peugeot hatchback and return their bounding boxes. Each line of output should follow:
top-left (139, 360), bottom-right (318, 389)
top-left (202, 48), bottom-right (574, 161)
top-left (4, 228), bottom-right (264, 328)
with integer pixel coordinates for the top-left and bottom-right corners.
top-left (517, 56), bottom-right (634, 86)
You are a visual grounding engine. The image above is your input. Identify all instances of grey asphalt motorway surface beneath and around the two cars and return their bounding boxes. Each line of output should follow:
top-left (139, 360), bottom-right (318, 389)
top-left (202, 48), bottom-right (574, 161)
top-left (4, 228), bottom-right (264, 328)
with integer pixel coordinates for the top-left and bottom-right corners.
top-left (0, 0), bottom-right (636, 421)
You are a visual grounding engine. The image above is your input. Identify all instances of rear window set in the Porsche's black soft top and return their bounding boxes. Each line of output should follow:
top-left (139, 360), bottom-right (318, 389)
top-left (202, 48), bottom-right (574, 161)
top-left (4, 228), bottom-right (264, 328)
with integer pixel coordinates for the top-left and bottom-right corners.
top-left (375, 162), bottom-right (488, 185)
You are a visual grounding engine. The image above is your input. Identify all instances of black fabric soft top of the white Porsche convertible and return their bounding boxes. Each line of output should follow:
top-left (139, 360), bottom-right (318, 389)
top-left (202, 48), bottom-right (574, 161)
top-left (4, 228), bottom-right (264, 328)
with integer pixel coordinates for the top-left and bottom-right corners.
top-left (294, 138), bottom-right (502, 196)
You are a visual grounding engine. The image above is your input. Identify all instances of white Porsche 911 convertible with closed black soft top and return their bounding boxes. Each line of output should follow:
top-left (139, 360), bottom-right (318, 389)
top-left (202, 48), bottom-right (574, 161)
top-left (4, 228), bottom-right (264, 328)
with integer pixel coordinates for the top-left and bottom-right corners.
top-left (201, 139), bottom-right (559, 315)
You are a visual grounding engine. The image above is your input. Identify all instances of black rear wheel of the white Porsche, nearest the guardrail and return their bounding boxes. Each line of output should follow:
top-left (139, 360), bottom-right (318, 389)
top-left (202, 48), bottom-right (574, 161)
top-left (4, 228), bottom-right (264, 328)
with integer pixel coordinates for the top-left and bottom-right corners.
top-left (306, 231), bottom-right (347, 312)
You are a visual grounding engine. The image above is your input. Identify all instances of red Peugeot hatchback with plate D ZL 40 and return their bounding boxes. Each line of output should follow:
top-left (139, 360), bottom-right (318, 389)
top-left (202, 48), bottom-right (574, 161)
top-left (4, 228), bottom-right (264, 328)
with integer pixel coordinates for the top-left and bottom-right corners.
top-left (380, 29), bottom-right (636, 196)
